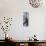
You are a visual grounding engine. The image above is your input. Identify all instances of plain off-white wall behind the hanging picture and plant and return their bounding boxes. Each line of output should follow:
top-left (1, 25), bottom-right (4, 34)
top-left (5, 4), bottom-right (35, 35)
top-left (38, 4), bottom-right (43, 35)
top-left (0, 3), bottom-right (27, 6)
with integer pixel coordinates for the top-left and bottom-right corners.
top-left (0, 0), bottom-right (46, 40)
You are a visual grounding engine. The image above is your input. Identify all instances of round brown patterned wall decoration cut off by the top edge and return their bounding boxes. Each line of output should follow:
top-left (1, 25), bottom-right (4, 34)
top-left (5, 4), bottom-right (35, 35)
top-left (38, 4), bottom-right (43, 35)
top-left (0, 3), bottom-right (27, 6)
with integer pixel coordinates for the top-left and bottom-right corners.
top-left (29, 0), bottom-right (45, 8)
